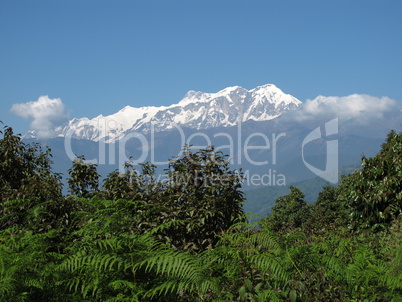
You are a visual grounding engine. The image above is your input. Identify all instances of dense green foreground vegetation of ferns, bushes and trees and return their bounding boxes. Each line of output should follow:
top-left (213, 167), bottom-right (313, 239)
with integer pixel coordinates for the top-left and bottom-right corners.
top-left (0, 127), bottom-right (402, 302)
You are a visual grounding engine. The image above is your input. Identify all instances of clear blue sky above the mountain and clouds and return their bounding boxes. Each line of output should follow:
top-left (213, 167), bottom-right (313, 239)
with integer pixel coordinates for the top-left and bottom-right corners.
top-left (0, 0), bottom-right (402, 132)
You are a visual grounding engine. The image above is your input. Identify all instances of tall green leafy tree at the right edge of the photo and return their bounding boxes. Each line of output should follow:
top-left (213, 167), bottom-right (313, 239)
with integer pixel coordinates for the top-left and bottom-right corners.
top-left (340, 131), bottom-right (402, 230)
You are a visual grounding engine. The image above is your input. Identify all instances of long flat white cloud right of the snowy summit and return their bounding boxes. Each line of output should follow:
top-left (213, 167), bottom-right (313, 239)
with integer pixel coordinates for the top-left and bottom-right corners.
top-left (295, 94), bottom-right (400, 124)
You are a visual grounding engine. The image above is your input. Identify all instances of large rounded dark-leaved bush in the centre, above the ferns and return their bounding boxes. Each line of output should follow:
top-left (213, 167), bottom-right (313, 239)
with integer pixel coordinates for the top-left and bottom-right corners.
top-left (163, 147), bottom-right (245, 251)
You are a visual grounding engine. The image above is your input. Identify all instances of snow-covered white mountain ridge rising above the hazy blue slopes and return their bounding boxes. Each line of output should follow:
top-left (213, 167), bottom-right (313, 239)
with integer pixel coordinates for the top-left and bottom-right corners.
top-left (28, 84), bottom-right (302, 142)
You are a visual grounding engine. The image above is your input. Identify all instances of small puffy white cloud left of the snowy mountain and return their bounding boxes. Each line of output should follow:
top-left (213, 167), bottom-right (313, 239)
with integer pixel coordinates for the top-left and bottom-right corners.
top-left (10, 95), bottom-right (68, 138)
